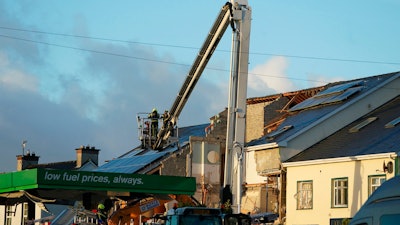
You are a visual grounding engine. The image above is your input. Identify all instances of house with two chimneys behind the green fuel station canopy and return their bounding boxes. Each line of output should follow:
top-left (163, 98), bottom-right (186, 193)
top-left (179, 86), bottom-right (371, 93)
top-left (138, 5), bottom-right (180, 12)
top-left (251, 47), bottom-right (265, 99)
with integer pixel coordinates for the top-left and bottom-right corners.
top-left (0, 146), bottom-right (100, 225)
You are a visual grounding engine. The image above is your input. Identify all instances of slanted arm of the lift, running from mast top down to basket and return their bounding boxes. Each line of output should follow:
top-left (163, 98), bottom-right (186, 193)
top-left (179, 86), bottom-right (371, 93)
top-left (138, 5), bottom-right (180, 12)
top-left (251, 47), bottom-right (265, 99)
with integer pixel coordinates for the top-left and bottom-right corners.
top-left (152, 2), bottom-right (232, 150)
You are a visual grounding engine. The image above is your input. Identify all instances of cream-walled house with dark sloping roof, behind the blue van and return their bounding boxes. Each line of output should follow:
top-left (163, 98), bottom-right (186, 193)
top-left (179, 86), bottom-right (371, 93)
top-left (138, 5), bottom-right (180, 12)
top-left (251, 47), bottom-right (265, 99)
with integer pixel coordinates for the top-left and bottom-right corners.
top-left (282, 95), bottom-right (400, 224)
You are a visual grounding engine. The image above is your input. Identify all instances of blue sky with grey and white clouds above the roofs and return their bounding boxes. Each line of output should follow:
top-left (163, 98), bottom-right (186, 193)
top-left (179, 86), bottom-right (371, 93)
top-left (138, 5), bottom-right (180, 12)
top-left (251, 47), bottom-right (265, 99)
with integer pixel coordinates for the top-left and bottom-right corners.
top-left (0, 0), bottom-right (400, 171)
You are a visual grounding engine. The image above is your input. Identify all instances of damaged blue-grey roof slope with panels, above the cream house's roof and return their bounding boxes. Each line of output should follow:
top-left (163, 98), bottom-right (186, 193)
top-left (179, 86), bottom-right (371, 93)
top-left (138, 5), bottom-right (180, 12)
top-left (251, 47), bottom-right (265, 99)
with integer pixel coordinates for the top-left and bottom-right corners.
top-left (247, 72), bottom-right (400, 146)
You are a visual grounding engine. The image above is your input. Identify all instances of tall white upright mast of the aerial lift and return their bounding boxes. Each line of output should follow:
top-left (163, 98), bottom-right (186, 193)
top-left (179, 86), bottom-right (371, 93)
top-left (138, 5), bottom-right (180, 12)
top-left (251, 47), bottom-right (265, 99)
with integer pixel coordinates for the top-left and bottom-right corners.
top-left (224, 1), bottom-right (251, 213)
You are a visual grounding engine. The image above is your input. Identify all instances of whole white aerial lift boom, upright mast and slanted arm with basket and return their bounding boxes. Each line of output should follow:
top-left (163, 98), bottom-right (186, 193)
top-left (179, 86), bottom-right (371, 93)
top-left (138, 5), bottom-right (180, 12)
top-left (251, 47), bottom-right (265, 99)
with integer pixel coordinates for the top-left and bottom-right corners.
top-left (138, 0), bottom-right (251, 213)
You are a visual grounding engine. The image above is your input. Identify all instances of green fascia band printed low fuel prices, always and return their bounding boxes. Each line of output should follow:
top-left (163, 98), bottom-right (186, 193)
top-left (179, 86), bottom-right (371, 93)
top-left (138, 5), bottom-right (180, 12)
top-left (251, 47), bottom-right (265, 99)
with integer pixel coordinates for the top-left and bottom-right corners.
top-left (0, 168), bottom-right (196, 195)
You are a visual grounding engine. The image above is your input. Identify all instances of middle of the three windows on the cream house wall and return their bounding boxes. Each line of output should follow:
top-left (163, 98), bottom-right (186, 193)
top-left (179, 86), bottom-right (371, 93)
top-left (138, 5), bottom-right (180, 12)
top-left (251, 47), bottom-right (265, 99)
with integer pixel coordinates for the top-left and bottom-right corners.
top-left (332, 178), bottom-right (348, 208)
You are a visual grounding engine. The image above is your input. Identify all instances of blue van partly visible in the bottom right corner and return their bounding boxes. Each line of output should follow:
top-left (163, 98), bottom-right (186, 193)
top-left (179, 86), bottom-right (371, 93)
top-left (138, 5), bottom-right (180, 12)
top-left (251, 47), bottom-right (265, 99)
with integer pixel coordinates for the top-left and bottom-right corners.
top-left (350, 176), bottom-right (400, 225)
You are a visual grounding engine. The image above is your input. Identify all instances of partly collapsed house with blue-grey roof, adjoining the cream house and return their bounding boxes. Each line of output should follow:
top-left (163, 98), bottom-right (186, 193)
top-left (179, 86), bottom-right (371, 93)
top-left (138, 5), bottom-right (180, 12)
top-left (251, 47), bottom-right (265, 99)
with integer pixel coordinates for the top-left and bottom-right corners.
top-left (242, 72), bottom-right (400, 221)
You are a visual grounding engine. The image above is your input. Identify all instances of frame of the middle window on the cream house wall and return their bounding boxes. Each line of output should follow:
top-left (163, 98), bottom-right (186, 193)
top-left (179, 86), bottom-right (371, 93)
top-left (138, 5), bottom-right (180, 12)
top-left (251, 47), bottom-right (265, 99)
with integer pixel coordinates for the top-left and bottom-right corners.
top-left (331, 177), bottom-right (349, 208)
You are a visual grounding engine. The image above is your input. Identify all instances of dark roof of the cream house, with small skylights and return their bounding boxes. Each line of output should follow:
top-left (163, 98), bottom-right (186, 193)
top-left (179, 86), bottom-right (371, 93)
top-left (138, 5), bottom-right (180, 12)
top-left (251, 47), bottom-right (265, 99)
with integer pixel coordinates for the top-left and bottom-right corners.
top-left (286, 97), bottom-right (400, 162)
